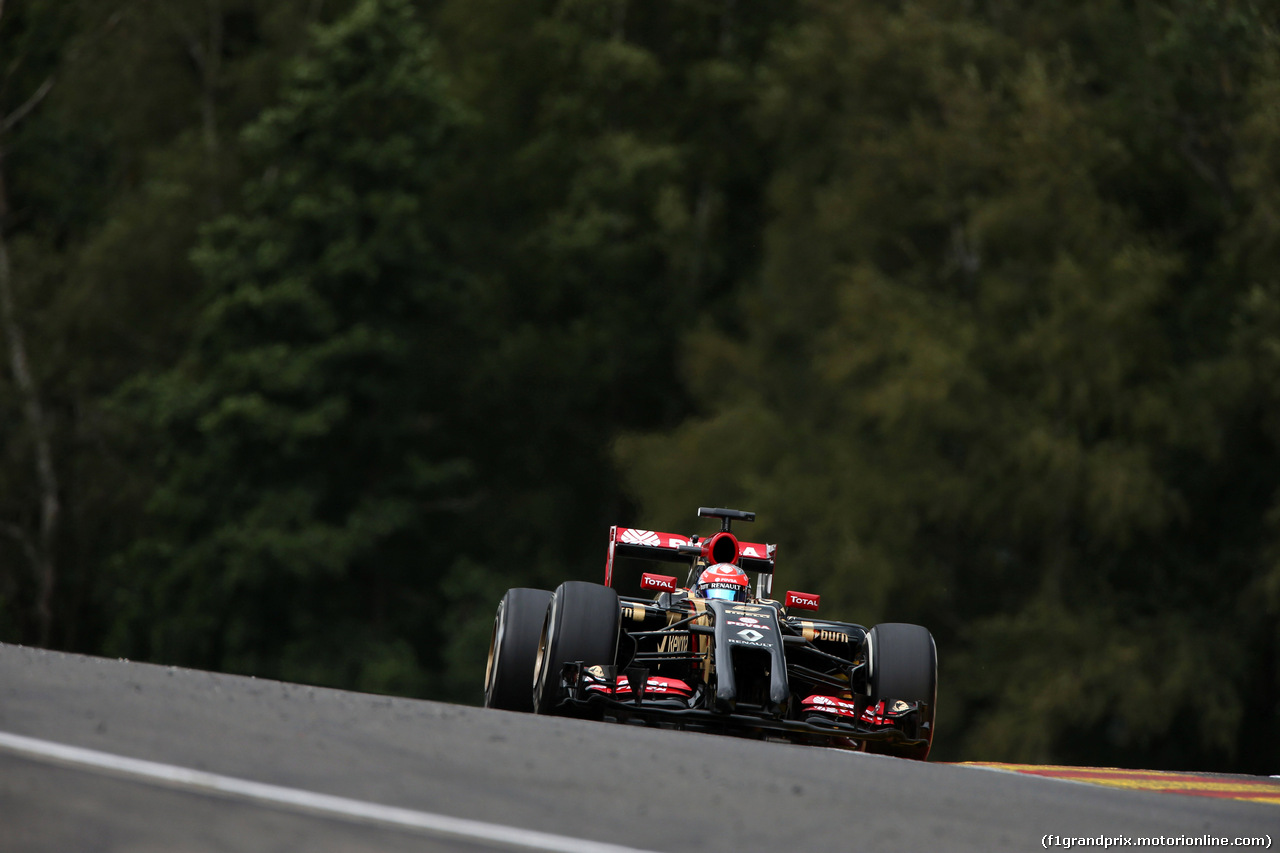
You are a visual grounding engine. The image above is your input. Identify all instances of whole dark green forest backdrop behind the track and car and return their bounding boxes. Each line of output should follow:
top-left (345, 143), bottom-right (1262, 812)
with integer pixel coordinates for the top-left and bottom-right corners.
top-left (0, 0), bottom-right (1280, 772)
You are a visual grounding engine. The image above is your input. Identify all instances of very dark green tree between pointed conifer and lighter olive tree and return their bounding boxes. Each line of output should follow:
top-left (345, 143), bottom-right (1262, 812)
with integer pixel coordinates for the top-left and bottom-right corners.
top-left (414, 0), bottom-right (794, 699)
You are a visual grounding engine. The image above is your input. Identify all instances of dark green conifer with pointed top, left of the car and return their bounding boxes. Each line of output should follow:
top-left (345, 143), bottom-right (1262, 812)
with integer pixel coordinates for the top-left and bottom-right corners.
top-left (116, 0), bottom-right (474, 692)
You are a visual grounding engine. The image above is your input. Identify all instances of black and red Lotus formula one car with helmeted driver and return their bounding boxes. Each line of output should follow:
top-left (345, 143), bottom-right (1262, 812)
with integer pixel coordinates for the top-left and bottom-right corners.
top-left (485, 507), bottom-right (937, 760)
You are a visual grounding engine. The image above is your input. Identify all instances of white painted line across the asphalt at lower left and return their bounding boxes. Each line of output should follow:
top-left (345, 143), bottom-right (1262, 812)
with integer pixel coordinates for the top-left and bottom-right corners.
top-left (0, 731), bottom-right (649, 853)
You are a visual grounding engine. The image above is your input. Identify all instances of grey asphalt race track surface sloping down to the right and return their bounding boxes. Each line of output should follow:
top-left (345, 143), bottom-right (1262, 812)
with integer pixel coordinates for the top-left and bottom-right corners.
top-left (0, 646), bottom-right (1280, 853)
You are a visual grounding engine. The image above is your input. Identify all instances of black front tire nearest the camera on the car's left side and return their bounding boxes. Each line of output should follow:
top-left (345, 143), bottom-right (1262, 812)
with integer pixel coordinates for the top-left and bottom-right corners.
top-left (532, 580), bottom-right (621, 713)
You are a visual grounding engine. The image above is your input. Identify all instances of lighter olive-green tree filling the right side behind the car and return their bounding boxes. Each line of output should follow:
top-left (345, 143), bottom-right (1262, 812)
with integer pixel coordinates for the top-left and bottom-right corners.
top-left (618, 0), bottom-right (1277, 768)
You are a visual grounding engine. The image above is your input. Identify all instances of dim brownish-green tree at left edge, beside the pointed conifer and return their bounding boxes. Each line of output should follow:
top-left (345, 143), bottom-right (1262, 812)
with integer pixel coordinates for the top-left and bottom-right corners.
top-left (0, 0), bottom-right (353, 651)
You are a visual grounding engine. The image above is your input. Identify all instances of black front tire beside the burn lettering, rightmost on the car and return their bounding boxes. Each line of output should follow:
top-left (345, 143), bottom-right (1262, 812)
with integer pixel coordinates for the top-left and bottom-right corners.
top-left (863, 622), bottom-right (938, 761)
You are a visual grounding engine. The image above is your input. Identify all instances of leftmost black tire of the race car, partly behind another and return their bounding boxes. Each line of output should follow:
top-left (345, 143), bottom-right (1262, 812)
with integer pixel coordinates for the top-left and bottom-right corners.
top-left (484, 588), bottom-right (552, 713)
